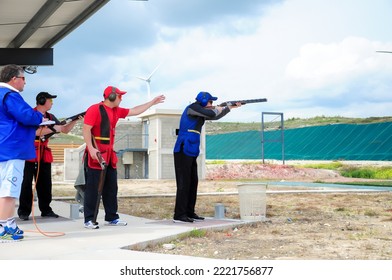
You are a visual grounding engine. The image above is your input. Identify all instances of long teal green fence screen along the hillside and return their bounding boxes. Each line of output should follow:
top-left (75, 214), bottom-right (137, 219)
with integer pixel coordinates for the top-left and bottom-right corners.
top-left (206, 122), bottom-right (392, 161)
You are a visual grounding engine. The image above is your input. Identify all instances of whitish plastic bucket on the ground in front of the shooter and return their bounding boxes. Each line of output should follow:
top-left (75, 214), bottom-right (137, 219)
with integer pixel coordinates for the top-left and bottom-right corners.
top-left (238, 183), bottom-right (267, 221)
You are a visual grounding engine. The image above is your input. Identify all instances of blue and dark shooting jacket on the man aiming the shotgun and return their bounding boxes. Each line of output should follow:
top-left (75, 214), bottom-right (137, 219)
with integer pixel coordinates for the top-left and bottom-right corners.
top-left (174, 102), bottom-right (230, 157)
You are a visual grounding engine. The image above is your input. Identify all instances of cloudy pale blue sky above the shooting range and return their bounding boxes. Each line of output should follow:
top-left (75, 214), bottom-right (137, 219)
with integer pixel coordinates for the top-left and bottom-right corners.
top-left (23, 0), bottom-right (392, 122)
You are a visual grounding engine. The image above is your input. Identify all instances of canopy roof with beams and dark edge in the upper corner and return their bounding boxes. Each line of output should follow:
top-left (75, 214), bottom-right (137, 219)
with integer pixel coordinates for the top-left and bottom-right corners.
top-left (0, 0), bottom-right (109, 65)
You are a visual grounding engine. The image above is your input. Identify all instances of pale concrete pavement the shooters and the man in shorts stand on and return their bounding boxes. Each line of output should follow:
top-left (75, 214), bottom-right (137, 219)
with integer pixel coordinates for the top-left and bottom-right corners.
top-left (0, 201), bottom-right (244, 260)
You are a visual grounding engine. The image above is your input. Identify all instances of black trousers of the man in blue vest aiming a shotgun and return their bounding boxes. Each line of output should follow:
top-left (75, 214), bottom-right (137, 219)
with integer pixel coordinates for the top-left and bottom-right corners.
top-left (173, 152), bottom-right (199, 219)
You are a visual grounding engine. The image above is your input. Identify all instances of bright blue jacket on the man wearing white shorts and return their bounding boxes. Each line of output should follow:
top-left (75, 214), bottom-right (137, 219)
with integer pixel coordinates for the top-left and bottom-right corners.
top-left (0, 86), bottom-right (42, 161)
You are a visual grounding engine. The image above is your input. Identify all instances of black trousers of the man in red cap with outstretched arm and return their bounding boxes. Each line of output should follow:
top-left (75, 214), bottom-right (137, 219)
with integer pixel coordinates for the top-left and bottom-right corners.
top-left (83, 164), bottom-right (119, 222)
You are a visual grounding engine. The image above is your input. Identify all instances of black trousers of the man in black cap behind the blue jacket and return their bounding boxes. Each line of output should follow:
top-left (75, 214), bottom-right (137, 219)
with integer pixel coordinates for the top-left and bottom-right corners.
top-left (18, 161), bottom-right (53, 216)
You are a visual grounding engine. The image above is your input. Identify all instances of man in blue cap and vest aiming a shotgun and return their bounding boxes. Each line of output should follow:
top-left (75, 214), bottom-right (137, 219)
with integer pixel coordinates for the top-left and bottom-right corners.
top-left (173, 91), bottom-right (241, 223)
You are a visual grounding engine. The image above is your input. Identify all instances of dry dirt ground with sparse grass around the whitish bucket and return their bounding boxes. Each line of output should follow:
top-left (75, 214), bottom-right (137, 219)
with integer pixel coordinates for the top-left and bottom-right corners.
top-left (52, 164), bottom-right (392, 260)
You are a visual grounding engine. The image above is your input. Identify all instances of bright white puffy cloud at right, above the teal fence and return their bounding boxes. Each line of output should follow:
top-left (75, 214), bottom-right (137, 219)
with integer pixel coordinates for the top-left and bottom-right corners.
top-left (286, 37), bottom-right (385, 88)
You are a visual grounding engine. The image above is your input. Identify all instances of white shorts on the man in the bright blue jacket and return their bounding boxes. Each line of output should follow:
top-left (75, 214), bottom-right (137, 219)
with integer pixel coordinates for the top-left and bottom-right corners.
top-left (0, 159), bottom-right (25, 198)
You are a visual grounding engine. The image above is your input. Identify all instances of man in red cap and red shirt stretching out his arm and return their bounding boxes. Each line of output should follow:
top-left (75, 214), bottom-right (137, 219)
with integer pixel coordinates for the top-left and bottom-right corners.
top-left (83, 86), bottom-right (165, 229)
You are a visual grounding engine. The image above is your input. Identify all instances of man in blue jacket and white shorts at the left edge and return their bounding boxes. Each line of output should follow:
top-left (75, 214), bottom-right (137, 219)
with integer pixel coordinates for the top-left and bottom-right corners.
top-left (0, 64), bottom-right (44, 243)
